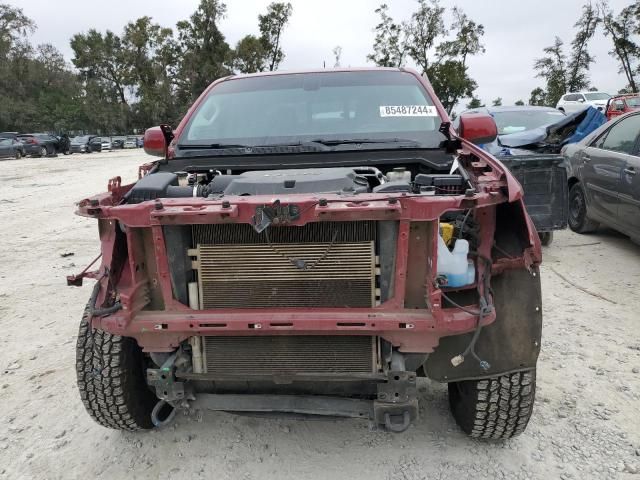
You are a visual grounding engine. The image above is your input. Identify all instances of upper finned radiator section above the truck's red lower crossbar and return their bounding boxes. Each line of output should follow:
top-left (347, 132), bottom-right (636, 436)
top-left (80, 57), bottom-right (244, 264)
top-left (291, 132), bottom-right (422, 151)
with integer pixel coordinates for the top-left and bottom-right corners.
top-left (191, 221), bottom-right (377, 309)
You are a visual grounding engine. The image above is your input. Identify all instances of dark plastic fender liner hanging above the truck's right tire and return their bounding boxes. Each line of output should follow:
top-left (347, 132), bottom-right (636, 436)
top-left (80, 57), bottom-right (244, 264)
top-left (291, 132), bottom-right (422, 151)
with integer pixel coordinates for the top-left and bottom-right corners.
top-left (424, 267), bottom-right (542, 382)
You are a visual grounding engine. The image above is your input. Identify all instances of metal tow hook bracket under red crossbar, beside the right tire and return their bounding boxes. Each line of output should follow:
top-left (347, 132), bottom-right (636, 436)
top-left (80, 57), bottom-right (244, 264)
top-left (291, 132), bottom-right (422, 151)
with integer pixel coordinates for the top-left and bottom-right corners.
top-left (373, 371), bottom-right (418, 433)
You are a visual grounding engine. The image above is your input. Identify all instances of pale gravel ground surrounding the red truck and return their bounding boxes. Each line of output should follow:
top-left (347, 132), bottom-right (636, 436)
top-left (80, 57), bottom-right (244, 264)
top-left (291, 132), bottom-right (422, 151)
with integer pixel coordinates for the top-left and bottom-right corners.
top-left (0, 150), bottom-right (640, 480)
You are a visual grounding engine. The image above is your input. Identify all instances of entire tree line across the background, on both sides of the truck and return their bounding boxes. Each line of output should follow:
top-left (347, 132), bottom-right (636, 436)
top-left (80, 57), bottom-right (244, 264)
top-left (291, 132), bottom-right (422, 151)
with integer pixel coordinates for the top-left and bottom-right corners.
top-left (0, 0), bottom-right (640, 133)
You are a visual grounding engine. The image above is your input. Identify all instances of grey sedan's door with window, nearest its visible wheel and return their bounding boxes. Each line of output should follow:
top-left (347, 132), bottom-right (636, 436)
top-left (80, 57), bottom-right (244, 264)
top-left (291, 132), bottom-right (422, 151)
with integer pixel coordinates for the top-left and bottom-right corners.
top-left (582, 115), bottom-right (640, 224)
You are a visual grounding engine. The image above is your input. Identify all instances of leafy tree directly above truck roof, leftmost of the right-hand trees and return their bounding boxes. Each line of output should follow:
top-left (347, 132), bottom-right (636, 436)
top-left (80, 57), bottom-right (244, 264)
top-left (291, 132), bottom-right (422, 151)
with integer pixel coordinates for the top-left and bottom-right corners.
top-left (367, 3), bottom-right (407, 67)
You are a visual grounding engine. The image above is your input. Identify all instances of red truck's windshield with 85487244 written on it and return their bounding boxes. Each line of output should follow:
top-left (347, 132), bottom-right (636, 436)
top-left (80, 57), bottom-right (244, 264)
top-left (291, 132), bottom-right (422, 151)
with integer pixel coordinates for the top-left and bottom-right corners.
top-left (180, 71), bottom-right (444, 148)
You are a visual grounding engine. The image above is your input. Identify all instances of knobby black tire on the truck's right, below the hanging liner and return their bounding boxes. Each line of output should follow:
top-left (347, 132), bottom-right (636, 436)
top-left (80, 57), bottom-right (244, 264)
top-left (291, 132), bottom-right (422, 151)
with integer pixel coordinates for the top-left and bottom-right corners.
top-left (449, 370), bottom-right (536, 440)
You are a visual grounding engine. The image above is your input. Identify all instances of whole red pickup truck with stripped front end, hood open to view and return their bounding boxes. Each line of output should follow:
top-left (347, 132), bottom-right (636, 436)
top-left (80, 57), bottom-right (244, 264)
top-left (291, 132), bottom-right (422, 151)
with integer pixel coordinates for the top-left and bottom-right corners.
top-left (68, 69), bottom-right (542, 439)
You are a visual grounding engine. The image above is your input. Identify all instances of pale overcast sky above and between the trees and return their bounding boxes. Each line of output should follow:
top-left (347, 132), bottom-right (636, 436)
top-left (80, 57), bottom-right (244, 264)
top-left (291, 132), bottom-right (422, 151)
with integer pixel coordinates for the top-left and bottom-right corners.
top-left (17, 0), bottom-right (631, 109)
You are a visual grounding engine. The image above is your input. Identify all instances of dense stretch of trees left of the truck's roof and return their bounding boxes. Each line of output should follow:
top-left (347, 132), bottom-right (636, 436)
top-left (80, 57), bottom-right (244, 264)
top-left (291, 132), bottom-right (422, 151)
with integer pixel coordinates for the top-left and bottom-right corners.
top-left (0, 0), bottom-right (292, 133)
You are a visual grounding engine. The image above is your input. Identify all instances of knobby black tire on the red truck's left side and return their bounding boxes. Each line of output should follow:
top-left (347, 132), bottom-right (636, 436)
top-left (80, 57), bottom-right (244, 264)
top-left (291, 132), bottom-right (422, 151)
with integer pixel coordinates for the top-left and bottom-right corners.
top-left (76, 307), bottom-right (158, 431)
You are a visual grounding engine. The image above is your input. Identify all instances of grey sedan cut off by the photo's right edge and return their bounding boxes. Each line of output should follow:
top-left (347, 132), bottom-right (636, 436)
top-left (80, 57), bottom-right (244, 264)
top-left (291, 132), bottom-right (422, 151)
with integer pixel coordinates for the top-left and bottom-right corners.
top-left (563, 111), bottom-right (640, 243)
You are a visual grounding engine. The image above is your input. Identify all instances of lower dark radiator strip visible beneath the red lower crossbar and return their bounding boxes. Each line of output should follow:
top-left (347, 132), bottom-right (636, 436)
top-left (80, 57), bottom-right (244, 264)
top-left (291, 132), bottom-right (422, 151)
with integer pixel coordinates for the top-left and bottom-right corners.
top-left (202, 335), bottom-right (377, 376)
